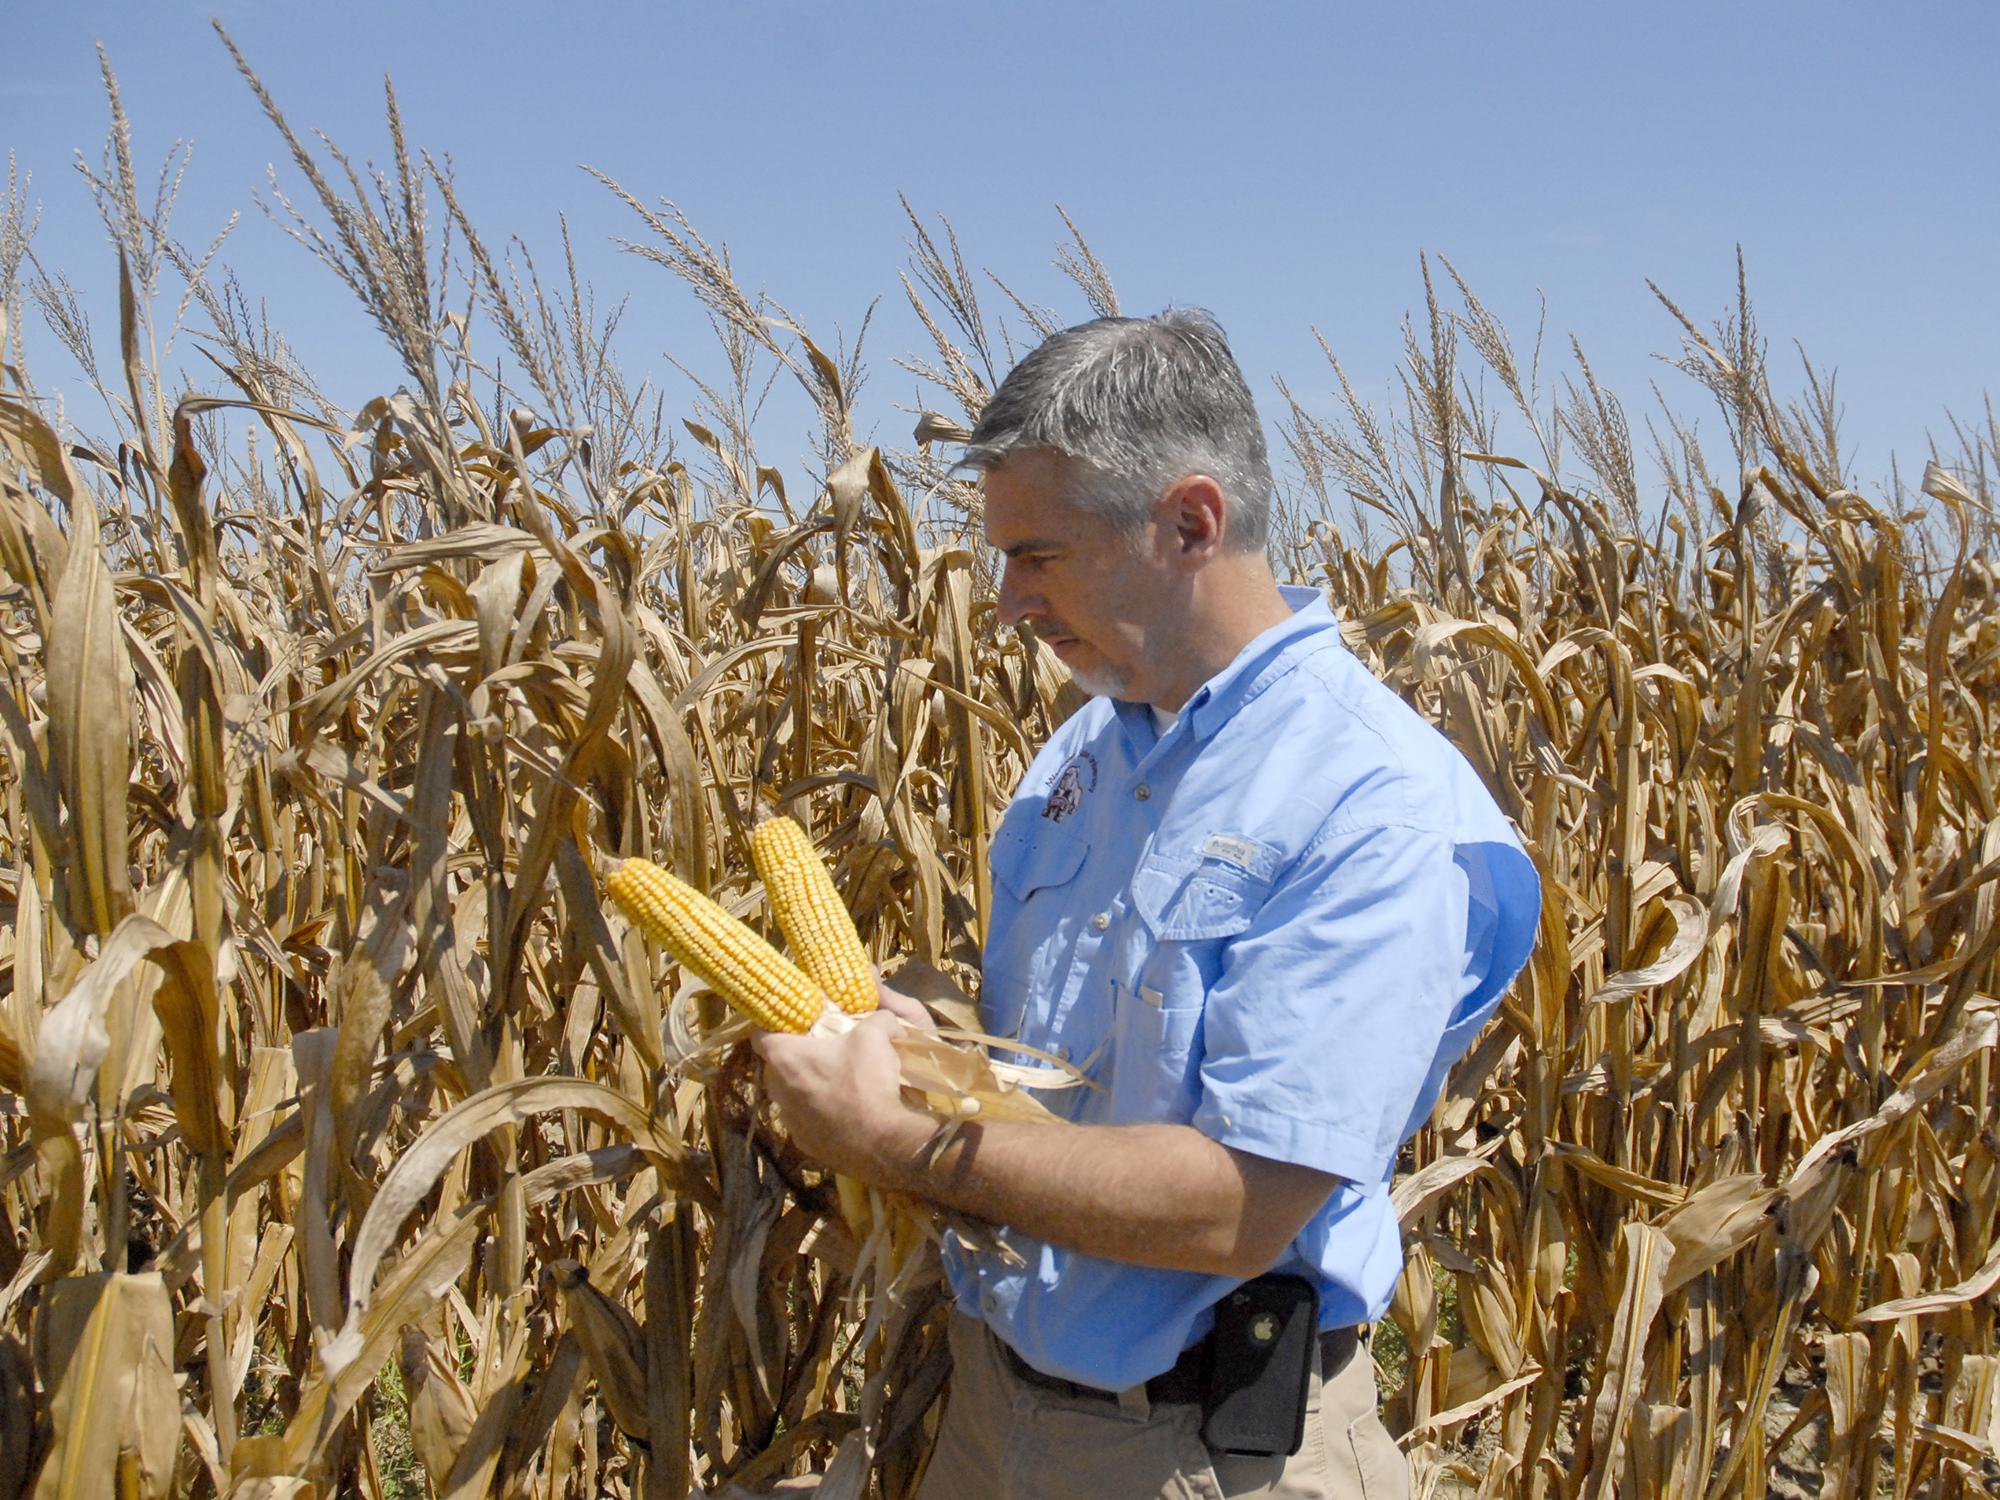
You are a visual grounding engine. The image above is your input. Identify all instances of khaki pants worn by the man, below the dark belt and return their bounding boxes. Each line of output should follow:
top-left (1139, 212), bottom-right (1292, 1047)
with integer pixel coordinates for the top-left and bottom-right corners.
top-left (918, 1312), bottom-right (1410, 1500)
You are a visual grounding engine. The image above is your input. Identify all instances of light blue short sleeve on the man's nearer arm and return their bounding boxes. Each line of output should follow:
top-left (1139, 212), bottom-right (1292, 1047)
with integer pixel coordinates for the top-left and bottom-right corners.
top-left (1194, 824), bottom-right (1540, 1186)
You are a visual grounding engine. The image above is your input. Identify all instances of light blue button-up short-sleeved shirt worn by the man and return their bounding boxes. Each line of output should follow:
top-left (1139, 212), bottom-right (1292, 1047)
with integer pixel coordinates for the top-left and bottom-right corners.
top-left (946, 588), bottom-right (1540, 1390)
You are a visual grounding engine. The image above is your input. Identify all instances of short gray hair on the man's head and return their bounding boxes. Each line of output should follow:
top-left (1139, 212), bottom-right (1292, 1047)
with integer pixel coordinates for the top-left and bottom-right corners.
top-left (960, 308), bottom-right (1272, 552)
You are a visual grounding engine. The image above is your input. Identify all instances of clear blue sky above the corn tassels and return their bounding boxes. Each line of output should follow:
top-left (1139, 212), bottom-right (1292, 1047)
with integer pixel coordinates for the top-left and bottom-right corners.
top-left (0, 0), bottom-right (2000, 494)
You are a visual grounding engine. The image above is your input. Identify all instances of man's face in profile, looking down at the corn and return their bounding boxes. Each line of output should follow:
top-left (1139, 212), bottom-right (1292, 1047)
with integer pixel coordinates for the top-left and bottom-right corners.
top-left (986, 448), bottom-right (1186, 702)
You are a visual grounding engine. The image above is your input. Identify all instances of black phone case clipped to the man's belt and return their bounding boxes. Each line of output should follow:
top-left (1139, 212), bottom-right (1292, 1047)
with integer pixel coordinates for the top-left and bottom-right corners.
top-left (1202, 1276), bottom-right (1320, 1458)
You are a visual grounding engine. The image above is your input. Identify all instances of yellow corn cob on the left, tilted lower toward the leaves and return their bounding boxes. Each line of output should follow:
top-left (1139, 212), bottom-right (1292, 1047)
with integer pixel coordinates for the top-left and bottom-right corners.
top-left (604, 860), bottom-right (826, 1032)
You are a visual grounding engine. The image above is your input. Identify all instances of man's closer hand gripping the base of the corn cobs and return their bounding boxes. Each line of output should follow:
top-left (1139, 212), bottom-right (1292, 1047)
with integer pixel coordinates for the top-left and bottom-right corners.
top-left (752, 1004), bottom-right (936, 1184)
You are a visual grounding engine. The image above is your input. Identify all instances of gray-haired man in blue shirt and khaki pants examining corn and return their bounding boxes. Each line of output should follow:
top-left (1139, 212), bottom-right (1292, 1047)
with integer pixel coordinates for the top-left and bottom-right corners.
top-left (758, 312), bottom-right (1540, 1500)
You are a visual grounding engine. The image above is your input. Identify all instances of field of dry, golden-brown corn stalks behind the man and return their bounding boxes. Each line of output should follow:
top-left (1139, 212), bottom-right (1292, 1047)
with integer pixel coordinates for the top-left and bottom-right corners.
top-left (0, 41), bottom-right (2000, 1500)
